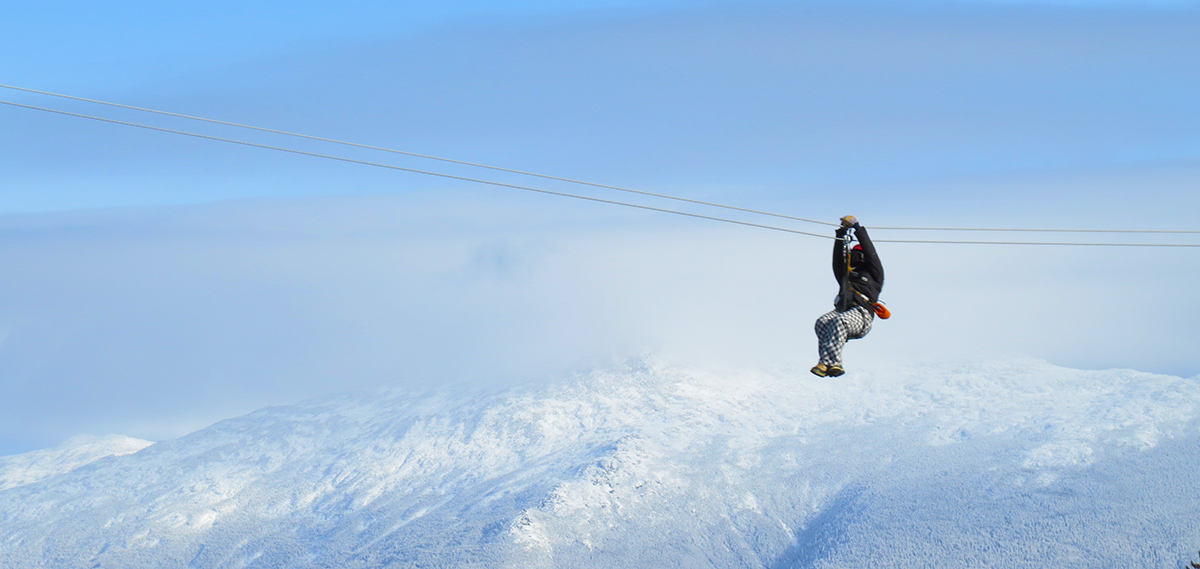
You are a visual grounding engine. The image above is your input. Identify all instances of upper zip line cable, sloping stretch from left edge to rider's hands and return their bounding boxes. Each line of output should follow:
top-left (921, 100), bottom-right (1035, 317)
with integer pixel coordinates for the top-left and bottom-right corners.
top-left (0, 84), bottom-right (838, 227)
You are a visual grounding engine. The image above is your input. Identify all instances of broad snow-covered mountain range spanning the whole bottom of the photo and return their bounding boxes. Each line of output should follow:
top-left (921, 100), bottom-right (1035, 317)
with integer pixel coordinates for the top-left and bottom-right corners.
top-left (0, 360), bottom-right (1200, 568)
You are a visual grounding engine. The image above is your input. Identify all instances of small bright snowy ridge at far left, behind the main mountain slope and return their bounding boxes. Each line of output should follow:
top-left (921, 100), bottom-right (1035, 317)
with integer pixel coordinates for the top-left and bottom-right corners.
top-left (0, 435), bottom-right (154, 490)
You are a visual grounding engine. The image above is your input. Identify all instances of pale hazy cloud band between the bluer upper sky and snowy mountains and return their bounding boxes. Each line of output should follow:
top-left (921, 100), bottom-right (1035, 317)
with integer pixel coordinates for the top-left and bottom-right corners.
top-left (0, 191), bottom-right (1196, 456)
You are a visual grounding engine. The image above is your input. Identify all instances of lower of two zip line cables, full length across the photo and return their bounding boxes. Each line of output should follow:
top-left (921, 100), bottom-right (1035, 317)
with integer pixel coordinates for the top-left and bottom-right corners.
top-left (0, 100), bottom-right (1200, 248)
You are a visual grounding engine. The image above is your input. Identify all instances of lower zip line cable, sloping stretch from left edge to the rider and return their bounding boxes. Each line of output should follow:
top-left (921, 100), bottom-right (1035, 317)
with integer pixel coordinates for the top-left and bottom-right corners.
top-left (0, 101), bottom-right (830, 238)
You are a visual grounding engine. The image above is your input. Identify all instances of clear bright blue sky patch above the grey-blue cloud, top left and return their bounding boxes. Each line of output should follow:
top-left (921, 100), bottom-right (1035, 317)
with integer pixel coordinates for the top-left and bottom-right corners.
top-left (4, 0), bottom-right (696, 89)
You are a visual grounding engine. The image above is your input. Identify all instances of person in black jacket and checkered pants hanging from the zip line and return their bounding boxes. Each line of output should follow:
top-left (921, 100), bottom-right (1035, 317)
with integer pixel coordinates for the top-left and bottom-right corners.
top-left (812, 215), bottom-right (889, 377)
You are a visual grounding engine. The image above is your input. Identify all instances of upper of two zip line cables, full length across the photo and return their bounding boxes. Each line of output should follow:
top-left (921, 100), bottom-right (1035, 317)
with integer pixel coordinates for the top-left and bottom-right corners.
top-left (9, 84), bottom-right (1200, 237)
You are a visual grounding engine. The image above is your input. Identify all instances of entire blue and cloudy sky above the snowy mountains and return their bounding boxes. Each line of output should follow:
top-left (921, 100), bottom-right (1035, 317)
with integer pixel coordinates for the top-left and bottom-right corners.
top-left (0, 1), bottom-right (1200, 453)
